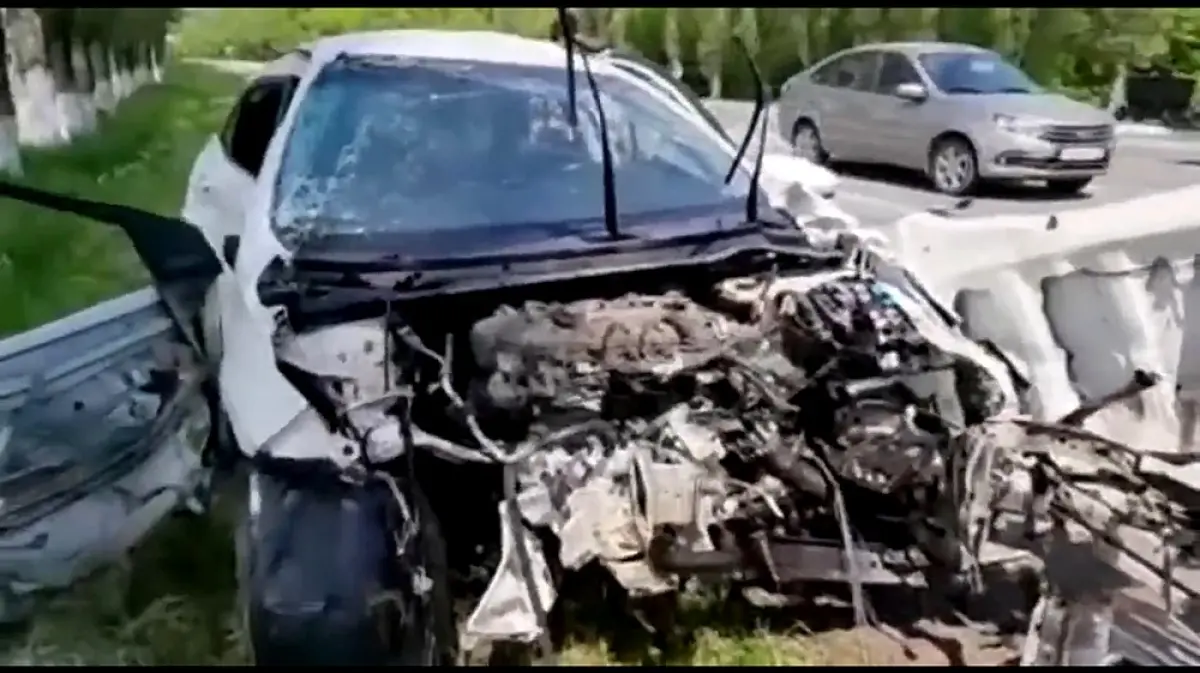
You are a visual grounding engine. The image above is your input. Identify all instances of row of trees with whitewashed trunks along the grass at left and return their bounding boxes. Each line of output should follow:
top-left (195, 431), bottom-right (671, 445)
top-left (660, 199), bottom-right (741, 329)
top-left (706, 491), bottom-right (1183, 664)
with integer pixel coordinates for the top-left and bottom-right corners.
top-left (0, 7), bottom-right (179, 173)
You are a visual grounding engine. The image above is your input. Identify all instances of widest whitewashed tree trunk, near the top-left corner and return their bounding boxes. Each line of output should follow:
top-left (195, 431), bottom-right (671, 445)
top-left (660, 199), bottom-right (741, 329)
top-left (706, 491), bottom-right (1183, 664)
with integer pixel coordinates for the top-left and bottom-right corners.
top-left (4, 7), bottom-right (70, 148)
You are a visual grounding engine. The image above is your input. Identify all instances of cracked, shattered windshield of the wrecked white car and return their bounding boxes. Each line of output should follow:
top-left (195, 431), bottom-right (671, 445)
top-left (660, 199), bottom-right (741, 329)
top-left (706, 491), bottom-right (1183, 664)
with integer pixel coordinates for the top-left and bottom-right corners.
top-left (272, 58), bottom-right (749, 245)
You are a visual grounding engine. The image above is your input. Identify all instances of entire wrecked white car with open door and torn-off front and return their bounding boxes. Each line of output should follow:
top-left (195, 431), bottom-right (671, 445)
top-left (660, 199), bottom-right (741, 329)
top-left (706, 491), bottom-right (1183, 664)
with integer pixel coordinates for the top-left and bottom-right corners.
top-left (0, 24), bottom-right (1195, 665)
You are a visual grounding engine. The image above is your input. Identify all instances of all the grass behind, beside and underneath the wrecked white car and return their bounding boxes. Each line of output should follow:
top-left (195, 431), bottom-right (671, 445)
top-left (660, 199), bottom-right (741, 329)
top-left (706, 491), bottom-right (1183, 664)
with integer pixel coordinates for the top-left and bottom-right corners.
top-left (0, 60), bottom-right (880, 666)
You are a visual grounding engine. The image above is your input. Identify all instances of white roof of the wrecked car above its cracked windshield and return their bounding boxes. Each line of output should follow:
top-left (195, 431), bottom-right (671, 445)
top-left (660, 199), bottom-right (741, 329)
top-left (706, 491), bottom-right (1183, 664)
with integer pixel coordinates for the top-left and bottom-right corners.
top-left (253, 30), bottom-right (611, 76)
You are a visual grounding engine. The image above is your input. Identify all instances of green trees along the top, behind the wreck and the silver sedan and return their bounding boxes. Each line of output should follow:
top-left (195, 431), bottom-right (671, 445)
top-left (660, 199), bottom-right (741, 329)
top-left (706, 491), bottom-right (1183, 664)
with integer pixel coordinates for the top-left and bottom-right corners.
top-left (181, 7), bottom-right (1200, 102)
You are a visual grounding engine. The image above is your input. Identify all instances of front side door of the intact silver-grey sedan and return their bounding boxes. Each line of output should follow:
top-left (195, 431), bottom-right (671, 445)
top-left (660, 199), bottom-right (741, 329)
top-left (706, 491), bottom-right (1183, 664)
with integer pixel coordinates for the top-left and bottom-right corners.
top-left (869, 52), bottom-right (932, 169)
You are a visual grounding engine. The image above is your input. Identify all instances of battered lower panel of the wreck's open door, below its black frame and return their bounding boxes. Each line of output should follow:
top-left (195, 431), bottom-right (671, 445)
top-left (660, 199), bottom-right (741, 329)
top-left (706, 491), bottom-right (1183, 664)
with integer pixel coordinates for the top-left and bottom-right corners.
top-left (0, 285), bottom-right (216, 623)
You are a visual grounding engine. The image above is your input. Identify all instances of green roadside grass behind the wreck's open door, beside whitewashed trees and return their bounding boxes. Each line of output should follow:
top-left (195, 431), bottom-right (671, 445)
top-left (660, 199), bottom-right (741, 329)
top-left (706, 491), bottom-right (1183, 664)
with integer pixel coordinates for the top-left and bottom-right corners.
top-left (0, 64), bottom-right (240, 336)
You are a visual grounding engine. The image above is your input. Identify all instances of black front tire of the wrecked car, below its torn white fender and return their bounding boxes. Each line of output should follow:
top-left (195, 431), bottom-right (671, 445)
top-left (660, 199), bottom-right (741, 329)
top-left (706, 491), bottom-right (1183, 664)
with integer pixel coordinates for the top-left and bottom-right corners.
top-left (238, 474), bottom-right (457, 666)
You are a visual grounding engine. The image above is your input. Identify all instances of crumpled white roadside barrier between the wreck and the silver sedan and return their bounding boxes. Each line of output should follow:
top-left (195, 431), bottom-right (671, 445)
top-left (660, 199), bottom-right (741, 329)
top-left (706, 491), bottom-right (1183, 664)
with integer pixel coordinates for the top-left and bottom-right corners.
top-left (884, 186), bottom-right (1200, 451)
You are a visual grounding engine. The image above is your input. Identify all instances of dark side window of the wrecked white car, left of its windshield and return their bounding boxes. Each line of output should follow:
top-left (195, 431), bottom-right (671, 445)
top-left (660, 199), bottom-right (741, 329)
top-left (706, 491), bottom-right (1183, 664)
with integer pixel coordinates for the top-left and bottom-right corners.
top-left (221, 77), bottom-right (299, 175)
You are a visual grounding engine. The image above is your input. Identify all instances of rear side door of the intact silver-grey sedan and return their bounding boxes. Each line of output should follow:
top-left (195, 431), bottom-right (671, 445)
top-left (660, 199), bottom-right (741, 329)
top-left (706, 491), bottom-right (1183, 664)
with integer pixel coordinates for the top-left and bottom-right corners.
top-left (798, 50), bottom-right (878, 161)
